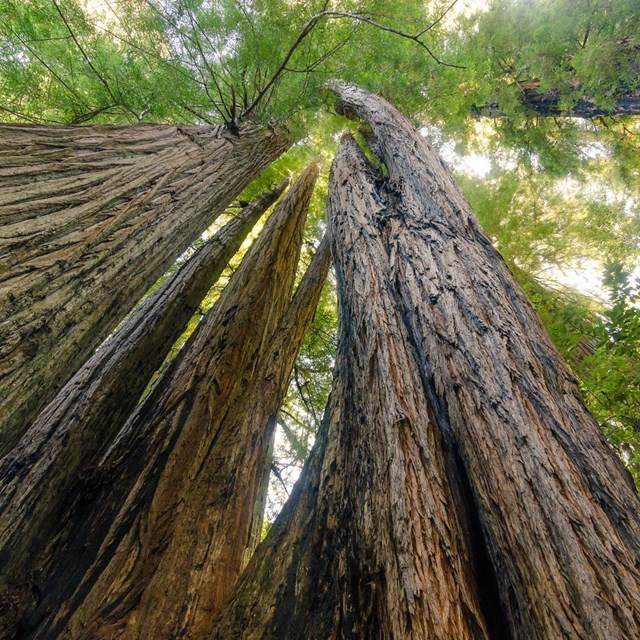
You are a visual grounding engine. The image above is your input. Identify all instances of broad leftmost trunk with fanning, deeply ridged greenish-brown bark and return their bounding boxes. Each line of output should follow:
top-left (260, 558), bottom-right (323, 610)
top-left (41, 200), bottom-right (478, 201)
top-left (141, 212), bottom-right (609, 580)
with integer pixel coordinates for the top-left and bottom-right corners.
top-left (0, 120), bottom-right (288, 455)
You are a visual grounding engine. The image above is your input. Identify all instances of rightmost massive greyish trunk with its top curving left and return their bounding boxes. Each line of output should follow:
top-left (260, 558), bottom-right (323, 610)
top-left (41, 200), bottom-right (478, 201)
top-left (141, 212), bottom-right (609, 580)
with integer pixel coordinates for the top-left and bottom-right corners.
top-left (334, 84), bottom-right (640, 640)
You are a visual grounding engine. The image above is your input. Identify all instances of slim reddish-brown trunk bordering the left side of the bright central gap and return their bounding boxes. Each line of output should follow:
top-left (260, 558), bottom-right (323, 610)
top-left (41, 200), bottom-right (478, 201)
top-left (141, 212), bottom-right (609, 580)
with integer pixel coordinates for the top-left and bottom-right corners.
top-left (112, 234), bottom-right (330, 640)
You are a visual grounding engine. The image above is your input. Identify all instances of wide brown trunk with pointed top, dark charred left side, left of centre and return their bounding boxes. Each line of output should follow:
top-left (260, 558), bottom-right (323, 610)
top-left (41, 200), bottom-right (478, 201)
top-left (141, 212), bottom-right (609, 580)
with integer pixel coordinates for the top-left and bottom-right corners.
top-left (23, 165), bottom-right (318, 638)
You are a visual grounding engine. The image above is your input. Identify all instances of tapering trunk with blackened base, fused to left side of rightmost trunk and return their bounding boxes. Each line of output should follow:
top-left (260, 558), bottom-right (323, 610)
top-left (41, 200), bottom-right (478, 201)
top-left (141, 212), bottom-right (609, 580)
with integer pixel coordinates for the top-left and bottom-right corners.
top-left (213, 132), bottom-right (489, 640)
